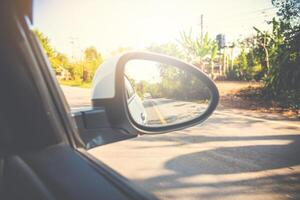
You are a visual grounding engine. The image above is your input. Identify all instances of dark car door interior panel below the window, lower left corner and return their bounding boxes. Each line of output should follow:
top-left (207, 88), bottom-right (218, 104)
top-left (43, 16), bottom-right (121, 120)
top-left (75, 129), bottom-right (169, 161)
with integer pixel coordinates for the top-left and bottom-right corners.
top-left (4, 145), bottom-right (129, 200)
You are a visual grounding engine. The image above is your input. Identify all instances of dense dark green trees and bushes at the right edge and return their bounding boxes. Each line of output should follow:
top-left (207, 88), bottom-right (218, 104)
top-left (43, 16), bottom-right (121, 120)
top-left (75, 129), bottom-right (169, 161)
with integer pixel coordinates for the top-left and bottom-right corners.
top-left (227, 0), bottom-right (300, 105)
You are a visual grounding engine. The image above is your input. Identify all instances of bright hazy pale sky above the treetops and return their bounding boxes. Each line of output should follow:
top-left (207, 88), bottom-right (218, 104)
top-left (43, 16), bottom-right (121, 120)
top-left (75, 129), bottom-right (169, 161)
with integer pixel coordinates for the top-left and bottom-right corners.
top-left (33, 0), bottom-right (276, 58)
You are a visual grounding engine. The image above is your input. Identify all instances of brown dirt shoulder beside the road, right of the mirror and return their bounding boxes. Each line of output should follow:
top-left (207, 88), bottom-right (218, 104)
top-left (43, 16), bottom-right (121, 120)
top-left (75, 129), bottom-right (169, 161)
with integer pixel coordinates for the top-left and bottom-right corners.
top-left (216, 81), bottom-right (300, 121)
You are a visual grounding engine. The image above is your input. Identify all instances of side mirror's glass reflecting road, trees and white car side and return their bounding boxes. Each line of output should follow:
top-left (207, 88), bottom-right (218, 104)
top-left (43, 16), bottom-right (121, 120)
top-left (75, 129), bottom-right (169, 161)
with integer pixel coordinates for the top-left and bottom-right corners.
top-left (124, 60), bottom-right (210, 127)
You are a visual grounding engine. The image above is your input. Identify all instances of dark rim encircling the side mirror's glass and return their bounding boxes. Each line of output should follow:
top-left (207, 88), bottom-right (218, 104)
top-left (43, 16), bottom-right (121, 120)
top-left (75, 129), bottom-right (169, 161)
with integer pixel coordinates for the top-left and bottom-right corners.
top-left (115, 52), bottom-right (219, 134)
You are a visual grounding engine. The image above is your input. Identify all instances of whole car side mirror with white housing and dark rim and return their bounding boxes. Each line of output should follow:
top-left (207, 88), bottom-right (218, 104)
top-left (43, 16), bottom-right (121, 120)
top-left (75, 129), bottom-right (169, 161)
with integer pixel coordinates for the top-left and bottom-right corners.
top-left (92, 52), bottom-right (219, 133)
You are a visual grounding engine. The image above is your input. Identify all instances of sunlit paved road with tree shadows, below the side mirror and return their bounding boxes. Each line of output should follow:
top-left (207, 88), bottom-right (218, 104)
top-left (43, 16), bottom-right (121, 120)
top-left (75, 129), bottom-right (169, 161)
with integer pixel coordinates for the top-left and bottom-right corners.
top-left (64, 88), bottom-right (300, 200)
